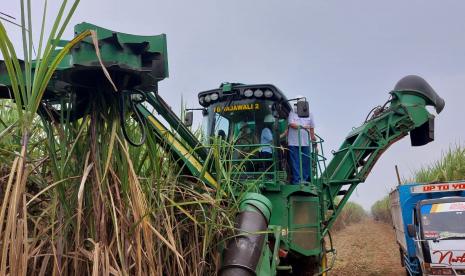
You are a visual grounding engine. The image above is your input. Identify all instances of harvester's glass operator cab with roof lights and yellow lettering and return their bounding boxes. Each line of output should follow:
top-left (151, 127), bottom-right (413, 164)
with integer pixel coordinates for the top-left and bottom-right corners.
top-left (198, 83), bottom-right (320, 186)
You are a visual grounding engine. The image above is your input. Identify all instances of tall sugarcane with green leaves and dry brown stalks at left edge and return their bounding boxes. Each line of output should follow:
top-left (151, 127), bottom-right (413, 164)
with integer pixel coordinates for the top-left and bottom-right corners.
top-left (0, 0), bottom-right (85, 275)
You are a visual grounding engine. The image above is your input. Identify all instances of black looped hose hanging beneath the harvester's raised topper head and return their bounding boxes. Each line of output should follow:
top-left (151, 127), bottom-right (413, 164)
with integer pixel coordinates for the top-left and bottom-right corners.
top-left (119, 90), bottom-right (147, 147)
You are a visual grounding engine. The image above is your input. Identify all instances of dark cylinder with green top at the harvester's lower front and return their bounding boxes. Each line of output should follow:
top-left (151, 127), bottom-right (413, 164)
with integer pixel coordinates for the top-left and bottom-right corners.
top-left (218, 193), bottom-right (272, 276)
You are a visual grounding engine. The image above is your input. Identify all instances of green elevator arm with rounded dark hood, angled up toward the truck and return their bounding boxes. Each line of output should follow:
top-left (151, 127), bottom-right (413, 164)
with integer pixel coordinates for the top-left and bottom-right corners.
top-left (321, 75), bottom-right (445, 233)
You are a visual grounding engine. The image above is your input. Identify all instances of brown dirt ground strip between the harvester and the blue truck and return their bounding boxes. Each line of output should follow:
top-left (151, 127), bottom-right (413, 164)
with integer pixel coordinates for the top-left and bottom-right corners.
top-left (329, 219), bottom-right (405, 276)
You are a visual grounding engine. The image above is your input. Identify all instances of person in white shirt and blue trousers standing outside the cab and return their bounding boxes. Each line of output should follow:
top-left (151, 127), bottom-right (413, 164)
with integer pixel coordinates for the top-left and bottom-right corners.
top-left (287, 96), bottom-right (316, 184)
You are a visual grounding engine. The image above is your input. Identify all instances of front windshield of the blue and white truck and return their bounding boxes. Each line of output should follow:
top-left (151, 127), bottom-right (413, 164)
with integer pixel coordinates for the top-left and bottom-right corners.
top-left (421, 201), bottom-right (465, 239)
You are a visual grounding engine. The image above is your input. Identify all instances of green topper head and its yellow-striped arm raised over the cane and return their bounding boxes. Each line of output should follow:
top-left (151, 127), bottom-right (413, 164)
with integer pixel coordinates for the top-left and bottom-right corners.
top-left (0, 23), bottom-right (216, 187)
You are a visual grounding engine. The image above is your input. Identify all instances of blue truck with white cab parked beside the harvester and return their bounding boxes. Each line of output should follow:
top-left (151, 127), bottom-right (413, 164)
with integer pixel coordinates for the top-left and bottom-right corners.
top-left (390, 181), bottom-right (465, 276)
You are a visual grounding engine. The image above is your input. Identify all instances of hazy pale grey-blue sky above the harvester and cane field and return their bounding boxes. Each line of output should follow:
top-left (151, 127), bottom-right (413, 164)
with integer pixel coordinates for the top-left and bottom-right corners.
top-left (0, 0), bottom-right (465, 210)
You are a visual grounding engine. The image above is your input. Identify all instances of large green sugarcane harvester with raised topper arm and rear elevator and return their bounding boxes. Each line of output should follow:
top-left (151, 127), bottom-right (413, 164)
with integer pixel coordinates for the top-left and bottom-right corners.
top-left (0, 23), bottom-right (444, 275)
